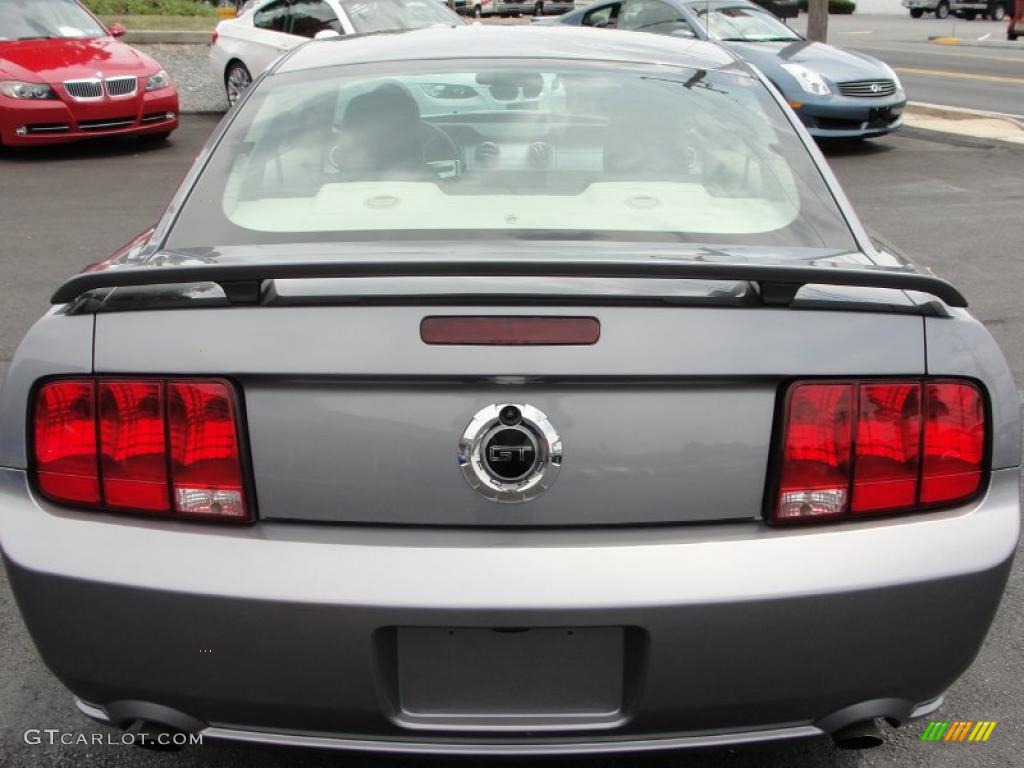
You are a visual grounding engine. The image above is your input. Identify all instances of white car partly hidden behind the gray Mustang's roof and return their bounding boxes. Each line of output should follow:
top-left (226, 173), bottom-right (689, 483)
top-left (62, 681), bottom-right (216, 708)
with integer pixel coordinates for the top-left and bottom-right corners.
top-left (210, 0), bottom-right (464, 106)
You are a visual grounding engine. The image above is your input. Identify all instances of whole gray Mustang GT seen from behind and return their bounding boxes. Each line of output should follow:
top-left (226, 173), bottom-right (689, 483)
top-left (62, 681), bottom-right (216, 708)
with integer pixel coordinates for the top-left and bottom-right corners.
top-left (0, 28), bottom-right (1020, 754)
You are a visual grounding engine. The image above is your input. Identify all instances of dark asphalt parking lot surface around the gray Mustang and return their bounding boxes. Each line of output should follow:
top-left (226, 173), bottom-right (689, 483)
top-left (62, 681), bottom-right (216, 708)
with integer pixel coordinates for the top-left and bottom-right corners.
top-left (0, 116), bottom-right (1024, 768)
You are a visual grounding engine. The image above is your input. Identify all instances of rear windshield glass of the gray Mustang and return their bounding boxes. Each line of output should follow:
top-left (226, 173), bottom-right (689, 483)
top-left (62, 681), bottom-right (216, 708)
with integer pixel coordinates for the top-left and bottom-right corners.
top-left (168, 60), bottom-right (855, 250)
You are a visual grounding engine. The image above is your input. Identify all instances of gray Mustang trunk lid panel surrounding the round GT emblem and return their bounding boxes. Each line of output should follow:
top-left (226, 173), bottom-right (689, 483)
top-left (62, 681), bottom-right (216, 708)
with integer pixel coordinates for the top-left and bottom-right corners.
top-left (95, 301), bottom-right (925, 526)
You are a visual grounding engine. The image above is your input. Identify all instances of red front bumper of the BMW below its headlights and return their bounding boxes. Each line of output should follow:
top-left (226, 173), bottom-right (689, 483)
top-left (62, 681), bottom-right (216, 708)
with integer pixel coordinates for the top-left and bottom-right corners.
top-left (0, 88), bottom-right (179, 146)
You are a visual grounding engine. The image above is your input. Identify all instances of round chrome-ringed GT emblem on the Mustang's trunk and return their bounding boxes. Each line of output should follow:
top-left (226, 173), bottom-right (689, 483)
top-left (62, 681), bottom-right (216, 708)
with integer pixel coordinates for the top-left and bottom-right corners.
top-left (459, 402), bottom-right (562, 503)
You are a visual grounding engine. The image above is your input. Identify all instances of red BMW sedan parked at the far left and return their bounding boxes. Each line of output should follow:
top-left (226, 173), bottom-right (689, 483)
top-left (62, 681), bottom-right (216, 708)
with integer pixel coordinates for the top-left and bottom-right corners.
top-left (0, 0), bottom-right (178, 146)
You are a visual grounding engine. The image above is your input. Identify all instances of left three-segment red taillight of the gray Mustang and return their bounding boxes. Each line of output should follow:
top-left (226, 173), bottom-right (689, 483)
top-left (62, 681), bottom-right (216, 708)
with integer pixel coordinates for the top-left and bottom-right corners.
top-left (33, 379), bottom-right (251, 521)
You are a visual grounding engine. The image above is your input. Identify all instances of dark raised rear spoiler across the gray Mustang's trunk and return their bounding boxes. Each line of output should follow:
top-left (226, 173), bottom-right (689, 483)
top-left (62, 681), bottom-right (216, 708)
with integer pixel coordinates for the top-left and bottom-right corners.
top-left (50, 258), bottom-right (967, 307)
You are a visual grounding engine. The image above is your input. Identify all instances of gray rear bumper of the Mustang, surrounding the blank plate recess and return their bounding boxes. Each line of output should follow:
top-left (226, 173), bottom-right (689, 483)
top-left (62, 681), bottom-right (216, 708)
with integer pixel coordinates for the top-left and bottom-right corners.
top-left (0, 469), bottom-right (1020, 754)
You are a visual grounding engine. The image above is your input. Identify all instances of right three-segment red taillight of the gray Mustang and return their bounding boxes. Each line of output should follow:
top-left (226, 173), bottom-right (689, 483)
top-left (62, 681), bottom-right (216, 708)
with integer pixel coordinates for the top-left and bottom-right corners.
top-left (772, 380), bottom-right (986, 522)
